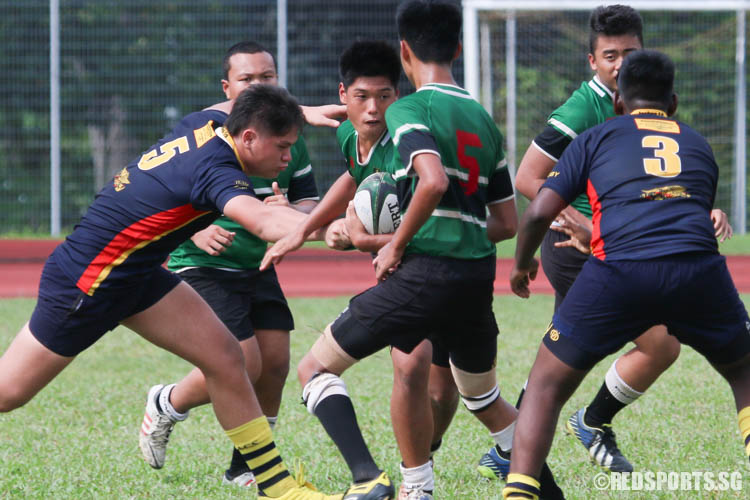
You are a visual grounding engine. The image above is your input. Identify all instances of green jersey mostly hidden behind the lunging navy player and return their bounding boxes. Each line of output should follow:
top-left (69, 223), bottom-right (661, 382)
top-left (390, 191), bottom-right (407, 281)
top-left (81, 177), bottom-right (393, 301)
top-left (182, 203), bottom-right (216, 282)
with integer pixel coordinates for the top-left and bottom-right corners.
top-left (168, 136), bottom-right (320, 272)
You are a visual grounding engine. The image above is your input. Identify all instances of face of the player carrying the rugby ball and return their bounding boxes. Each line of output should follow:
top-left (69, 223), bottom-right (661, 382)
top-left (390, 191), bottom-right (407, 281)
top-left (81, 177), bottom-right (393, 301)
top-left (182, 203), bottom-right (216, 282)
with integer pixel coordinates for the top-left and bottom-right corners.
top-left (339, 76), bottom-right (398, 142)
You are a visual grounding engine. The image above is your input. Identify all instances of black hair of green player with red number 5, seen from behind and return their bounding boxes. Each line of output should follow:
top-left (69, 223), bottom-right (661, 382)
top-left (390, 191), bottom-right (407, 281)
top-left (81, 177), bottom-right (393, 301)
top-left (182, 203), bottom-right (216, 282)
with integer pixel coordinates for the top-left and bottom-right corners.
top-left (396, 0), bottom-right (462, 64)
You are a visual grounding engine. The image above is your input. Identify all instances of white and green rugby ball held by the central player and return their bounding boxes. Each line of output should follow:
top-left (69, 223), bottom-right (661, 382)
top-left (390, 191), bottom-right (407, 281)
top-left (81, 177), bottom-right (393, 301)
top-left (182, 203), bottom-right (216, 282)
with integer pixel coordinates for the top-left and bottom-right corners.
top-left (354, 172), bottom-right (401, 234)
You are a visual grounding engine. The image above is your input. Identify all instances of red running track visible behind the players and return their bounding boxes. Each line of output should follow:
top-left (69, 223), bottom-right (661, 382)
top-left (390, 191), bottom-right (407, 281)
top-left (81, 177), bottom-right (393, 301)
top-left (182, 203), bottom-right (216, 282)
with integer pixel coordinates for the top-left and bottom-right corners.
top-left (0, 240), bottom-right (750, 297)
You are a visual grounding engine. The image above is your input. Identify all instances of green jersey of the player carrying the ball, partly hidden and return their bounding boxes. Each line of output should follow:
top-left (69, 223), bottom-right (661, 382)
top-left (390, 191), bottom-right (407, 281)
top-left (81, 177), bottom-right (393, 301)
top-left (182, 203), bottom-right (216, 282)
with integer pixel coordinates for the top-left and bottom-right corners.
top-left (336, 120), bottom-right (393, 186)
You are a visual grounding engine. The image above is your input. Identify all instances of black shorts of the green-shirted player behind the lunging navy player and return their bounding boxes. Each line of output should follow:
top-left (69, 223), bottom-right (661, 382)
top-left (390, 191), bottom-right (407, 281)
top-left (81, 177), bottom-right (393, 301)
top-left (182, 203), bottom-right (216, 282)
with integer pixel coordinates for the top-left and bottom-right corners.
top-left (179, 267), bottom-right (294, 340)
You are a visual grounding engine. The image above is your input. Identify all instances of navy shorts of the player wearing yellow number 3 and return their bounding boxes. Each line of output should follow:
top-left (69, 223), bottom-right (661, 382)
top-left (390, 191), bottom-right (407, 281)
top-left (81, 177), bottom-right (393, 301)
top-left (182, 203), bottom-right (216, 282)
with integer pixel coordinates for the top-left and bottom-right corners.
top-left (544, 253), bottom-right (750, 370)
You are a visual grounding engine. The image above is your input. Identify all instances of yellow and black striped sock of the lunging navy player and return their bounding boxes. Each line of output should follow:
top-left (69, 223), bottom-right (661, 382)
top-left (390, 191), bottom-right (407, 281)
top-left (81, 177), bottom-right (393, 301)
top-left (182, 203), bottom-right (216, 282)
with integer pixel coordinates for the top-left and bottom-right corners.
top-left (226, 417), bottom-right (297, 497)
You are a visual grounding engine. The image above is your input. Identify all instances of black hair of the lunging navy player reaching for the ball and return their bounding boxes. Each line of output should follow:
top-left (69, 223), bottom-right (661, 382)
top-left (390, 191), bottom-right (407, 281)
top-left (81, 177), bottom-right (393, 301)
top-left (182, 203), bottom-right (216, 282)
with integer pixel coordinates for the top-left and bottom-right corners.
top-left (224, 84), bottom-right (305, 137)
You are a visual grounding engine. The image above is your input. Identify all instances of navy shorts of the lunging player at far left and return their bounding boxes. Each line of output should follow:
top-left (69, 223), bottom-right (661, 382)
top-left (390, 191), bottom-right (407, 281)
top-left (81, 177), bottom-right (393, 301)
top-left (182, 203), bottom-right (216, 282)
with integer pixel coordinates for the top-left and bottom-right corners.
top-left (29, 255), bottom-right (180, 356)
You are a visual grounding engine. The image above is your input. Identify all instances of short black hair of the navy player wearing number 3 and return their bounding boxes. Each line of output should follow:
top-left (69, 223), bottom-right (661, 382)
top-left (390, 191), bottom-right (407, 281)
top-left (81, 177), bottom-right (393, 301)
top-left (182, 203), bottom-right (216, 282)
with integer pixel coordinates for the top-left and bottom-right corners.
top-left (617, 50), bottom-right (674, 110)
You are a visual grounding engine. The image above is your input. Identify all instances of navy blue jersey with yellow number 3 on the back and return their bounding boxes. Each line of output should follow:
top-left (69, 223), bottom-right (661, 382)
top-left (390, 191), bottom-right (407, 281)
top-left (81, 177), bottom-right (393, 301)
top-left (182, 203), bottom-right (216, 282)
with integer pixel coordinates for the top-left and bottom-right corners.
top-left (542, 110), bottom-right (719, 260)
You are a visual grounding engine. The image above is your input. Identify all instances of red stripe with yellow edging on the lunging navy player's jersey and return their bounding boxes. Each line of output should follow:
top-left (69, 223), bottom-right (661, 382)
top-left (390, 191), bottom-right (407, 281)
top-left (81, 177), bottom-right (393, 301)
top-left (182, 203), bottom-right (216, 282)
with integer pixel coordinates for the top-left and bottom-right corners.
top-left (76, 204), bottom-right (208, 295)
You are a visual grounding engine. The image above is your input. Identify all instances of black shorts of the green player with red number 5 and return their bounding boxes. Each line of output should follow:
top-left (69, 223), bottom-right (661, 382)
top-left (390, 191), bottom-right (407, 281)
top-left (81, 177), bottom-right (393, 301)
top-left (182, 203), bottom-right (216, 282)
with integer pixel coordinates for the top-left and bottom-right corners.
top-left (331, 255), bottom-right (498, 373)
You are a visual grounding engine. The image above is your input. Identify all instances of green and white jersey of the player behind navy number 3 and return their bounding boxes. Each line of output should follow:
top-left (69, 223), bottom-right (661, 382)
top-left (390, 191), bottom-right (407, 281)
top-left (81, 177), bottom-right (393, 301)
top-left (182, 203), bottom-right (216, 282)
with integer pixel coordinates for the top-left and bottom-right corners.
top-left (532, 76), bottom-right (615, 219)
